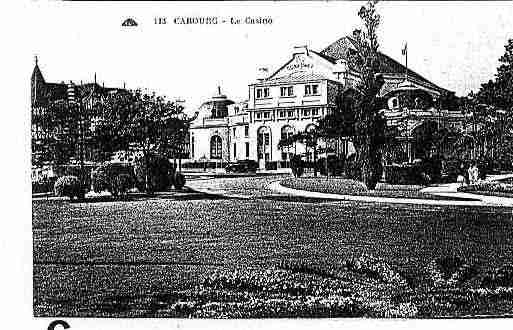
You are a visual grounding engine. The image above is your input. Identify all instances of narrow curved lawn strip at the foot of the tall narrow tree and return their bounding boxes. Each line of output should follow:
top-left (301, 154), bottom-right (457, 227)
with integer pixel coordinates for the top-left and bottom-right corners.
top-left (280, 177), bottom-right (474, 200)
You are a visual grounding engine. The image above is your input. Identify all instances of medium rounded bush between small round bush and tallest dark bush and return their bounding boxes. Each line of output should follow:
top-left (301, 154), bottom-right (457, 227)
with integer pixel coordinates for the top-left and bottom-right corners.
top-left (91, 162), bottom-right (134, 196)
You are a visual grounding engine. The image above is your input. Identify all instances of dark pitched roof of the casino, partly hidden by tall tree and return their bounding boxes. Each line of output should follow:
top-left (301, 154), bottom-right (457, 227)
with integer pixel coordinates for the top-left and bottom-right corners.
top-left (320, 36), bottom-right (448, 92)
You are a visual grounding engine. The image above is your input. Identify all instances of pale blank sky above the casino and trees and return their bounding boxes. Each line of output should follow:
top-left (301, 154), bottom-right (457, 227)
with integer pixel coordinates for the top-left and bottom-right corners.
top-left (26, 1), bottom-right (513, 111)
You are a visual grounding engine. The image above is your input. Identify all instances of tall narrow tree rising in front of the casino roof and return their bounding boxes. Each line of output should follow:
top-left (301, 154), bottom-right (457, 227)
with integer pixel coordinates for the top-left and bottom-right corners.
top-left (319, 0), bottom-right (387, 189)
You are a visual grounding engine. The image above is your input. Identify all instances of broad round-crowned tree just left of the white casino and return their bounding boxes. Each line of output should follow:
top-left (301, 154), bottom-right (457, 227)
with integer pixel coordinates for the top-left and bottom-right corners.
top-left (95, 90), bottom-right (191, 192)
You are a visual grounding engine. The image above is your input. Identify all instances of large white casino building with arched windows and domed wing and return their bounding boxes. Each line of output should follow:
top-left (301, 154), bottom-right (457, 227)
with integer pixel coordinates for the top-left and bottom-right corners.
top-left (186, 37), bottom-right (462, 169)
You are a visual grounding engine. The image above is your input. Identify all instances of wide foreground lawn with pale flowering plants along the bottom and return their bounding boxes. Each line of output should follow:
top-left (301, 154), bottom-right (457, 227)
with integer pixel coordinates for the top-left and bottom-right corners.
top-left (33, 196), bottom-right (513, 317)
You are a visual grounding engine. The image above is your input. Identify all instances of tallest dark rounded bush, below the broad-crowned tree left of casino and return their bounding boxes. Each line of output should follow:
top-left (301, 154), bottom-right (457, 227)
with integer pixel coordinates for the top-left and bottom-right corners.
top-left (134, 154), bottom-right (175, 192)
